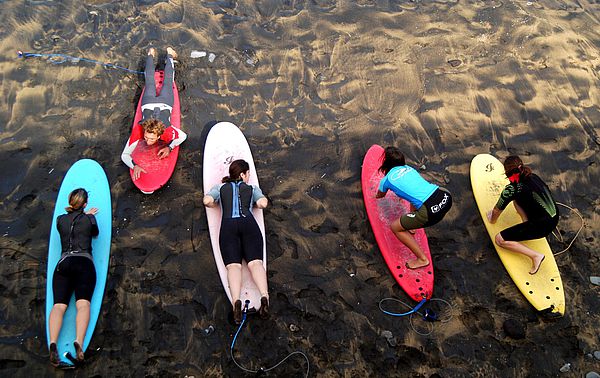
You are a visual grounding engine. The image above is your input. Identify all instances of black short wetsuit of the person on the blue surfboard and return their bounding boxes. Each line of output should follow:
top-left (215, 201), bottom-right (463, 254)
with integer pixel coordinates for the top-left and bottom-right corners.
top-left (52, 209), bottom-right (99, 305)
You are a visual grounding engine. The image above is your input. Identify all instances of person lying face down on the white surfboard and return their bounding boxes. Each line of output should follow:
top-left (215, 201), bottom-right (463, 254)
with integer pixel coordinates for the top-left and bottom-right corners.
top-left (203, 159), bottom-right (269, 324)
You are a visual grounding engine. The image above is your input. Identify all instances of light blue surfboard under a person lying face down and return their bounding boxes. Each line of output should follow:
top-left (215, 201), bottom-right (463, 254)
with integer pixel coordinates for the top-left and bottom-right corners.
top-left (46, 159), bottom-right (112, 365)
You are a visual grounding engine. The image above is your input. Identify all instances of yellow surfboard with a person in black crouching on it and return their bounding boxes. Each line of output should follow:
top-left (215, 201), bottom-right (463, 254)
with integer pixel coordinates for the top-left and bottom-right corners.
top-left (471, 154), bottom-right (565, 315)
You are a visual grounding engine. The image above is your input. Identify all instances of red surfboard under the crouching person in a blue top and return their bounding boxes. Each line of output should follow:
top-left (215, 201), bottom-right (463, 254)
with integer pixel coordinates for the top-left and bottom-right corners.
top-left (361, 144), bottom-right (433, 302)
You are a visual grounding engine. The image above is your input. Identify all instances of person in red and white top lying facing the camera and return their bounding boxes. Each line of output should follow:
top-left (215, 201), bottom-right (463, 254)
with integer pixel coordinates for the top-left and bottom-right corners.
top-left (121, 47), bottom-right (187, 180)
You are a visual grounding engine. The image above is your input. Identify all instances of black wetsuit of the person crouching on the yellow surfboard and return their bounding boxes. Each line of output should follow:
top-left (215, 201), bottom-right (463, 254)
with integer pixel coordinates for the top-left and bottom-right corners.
top-left (496, 173), bottom-right (559, 241)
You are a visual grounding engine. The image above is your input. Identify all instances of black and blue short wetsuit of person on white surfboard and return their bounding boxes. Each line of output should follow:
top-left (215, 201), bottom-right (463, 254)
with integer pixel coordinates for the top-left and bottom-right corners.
top-left (207, 180), bottom-right (264, 266)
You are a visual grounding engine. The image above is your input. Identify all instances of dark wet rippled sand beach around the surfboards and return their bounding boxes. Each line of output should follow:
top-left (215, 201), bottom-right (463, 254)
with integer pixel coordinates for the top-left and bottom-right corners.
top-left (0, 0), bottom-right (600, 377)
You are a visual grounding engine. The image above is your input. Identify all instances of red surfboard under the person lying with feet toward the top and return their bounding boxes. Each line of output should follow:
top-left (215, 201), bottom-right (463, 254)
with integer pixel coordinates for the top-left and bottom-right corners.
top-left (129, 71), bottom-right (181, 194)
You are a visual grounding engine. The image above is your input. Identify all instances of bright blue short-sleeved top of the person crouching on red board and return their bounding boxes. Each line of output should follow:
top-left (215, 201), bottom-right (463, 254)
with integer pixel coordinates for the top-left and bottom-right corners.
top-left (379, 165), bottom-right (439, 210)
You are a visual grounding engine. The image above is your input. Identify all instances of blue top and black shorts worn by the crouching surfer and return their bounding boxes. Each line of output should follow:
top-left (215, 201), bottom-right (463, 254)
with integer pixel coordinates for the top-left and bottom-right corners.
top-left (379, 165), bottom-right (452, 230)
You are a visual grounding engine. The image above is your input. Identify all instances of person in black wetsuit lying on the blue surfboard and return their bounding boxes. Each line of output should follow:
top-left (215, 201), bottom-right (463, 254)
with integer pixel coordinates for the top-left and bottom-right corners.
top-left (48, 188), bottom-right (99, 366)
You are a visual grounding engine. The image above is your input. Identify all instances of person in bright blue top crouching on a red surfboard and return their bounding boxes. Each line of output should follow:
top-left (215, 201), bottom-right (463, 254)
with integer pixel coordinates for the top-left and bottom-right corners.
top-left (375, 147), bottom-right (452, 269)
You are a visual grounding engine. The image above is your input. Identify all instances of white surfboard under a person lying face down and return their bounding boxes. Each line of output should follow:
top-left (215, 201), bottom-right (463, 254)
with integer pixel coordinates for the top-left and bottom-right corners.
top-left (203, 122), bottom-right (267, 311)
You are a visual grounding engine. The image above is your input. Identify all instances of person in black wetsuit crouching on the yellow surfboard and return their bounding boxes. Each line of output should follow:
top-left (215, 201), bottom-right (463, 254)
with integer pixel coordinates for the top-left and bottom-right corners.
top-left (487, 156), bottom-right (559, 274)
